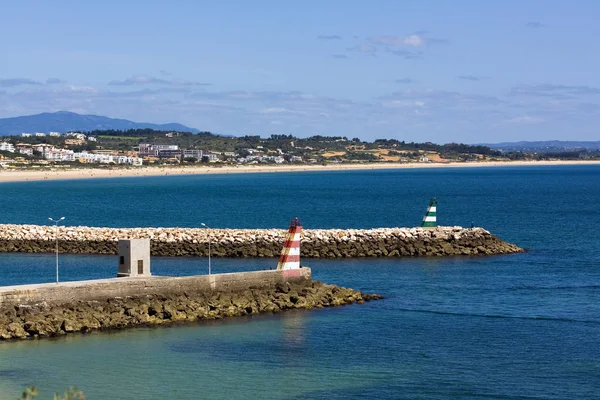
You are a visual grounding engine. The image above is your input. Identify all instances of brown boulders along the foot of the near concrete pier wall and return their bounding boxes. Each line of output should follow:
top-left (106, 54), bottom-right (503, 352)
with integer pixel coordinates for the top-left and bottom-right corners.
top-left (0, 280), bottom-right (382, 340)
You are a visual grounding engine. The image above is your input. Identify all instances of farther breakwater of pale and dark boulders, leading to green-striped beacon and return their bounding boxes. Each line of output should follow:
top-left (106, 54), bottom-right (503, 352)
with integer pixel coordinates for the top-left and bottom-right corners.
top-left (0, 225), bottom-right (523, 258)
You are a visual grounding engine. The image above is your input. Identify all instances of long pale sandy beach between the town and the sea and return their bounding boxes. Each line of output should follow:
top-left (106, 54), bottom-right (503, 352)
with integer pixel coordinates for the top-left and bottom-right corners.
top-left (0, 160), bottom-right (600, 183)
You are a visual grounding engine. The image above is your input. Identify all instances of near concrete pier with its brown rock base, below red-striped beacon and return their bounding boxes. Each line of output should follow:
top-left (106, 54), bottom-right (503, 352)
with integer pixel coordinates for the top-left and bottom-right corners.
top-left (0, 268), bottom-right (382, 340)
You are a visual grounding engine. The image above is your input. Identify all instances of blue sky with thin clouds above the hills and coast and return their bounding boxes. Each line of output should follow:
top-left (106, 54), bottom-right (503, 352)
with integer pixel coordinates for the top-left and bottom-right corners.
top-left (0, 0), bottom-right (600, 143)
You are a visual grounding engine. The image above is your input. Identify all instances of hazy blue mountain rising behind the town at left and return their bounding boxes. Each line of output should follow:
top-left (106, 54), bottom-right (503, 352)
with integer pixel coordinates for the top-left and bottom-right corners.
top-left (0, 111), bottom-right (199, 136)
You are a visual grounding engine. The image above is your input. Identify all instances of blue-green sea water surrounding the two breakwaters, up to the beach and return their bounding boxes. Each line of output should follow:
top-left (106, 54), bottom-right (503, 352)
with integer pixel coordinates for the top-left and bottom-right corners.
top-left (0, 166), bottom-right (600, 399)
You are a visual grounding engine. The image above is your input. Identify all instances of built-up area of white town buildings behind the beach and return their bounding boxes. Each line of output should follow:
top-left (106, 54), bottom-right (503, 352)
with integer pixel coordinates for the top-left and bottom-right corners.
top-left (0, 132), bottom-right (446, 168)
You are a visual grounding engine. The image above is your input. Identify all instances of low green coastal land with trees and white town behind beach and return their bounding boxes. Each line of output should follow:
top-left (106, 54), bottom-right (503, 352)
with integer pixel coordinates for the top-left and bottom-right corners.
top-left (0, 129), bottom-right (593, 169)
